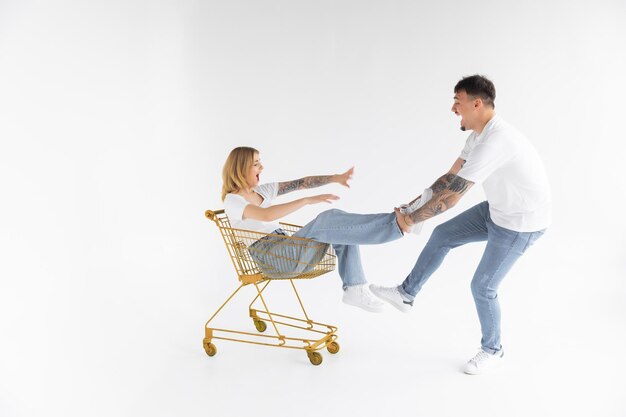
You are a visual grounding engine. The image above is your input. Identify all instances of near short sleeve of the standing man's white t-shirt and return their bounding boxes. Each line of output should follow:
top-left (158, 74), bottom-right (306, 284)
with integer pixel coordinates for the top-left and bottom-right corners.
top-left (457, 139), bottom-right (511, 183)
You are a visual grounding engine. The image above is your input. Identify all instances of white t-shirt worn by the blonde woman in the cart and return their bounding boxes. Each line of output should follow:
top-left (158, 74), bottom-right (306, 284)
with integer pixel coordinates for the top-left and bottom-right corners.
top-left (224, 182), bottom-right (280, 233)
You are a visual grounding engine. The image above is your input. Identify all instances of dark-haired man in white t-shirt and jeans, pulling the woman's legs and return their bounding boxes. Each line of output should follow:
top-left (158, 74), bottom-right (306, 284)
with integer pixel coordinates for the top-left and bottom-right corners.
top-left (371, 75), bottom-right (551, 374)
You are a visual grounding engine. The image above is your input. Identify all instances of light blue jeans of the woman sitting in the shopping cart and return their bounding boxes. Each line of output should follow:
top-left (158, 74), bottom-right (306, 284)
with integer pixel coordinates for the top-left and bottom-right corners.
top-left (251, 209), bottom-right (403, 289)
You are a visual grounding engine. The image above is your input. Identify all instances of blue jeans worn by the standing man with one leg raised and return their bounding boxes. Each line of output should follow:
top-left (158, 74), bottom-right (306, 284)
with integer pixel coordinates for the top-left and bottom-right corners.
top-left (399, 201), bottom-right (544, 353)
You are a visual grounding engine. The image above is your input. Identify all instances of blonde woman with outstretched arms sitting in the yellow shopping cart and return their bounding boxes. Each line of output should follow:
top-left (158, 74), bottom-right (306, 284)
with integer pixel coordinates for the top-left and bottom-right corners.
top-left (222, 147), bottom-right (403, 312)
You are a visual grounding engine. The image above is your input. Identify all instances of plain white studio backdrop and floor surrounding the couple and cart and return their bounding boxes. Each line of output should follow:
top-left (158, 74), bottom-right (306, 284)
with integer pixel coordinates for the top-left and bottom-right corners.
top-left (0, 0), bottom-right (626, 417)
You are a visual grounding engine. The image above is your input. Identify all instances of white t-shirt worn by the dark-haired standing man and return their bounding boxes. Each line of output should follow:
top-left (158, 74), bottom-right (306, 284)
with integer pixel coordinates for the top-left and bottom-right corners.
top-left (457, 115), bottom-right (552, 232)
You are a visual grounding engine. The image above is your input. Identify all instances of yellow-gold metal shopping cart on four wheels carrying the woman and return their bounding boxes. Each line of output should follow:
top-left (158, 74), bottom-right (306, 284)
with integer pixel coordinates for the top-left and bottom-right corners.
top-left (203, 210), bottom-right (339, 365)
